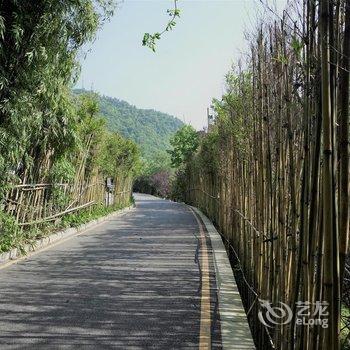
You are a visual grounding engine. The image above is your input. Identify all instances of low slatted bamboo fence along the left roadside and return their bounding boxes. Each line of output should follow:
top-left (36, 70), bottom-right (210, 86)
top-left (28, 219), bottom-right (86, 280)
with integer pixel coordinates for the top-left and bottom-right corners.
top-left (3, 177), bottom-right (132, 226)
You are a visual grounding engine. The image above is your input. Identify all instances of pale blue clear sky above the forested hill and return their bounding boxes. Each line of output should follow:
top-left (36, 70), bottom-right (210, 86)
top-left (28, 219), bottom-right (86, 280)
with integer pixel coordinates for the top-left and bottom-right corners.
top-left (76, 0), bottom-right (284, 130)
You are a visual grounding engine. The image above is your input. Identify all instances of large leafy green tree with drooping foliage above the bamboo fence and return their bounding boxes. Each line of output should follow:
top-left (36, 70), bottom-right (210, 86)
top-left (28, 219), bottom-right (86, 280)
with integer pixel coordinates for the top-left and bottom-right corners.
top-left (0, 0), bottom-right (113, 186)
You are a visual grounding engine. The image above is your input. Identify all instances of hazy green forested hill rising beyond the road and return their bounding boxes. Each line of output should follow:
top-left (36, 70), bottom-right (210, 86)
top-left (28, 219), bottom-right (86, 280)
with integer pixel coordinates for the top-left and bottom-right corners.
top-left (75, 90), bottom-right (183, 159)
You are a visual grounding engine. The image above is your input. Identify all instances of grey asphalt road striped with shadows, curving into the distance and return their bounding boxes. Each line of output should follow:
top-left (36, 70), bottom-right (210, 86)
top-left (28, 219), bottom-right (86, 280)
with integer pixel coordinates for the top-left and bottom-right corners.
top-left (0, 195), bottom-right (221, 350)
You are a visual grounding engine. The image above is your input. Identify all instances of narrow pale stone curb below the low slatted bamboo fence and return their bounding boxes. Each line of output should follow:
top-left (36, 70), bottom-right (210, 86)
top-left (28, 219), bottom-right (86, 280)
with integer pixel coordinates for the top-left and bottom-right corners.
top-left (0, 204), bottom-right (135, 268)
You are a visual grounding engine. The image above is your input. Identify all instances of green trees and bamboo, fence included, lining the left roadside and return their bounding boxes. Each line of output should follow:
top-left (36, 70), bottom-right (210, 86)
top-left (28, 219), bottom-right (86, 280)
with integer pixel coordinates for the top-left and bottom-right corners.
top-left (0, 0), bottom-right (139, 251)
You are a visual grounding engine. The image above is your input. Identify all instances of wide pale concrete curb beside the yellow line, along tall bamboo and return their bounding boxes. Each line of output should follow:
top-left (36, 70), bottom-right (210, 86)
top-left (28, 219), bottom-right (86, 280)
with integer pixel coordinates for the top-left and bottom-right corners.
top-left (191, 207), bottom-right (256, 350)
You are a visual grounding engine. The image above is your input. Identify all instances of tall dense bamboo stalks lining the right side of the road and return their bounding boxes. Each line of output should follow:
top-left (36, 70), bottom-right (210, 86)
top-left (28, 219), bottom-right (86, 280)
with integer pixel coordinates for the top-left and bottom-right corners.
top-left (178, 0), bottom-right (350, 350)
